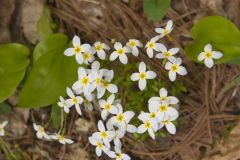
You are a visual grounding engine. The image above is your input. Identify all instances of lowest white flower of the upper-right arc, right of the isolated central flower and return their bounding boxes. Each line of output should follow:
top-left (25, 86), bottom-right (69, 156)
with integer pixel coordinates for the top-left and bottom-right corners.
top-left (165, 58), bottom-right (187, 81)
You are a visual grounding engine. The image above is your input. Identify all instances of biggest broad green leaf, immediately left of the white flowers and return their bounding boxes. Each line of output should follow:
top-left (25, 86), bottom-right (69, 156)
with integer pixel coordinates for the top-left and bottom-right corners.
top-left (19, 34), bottom-right (78, 107)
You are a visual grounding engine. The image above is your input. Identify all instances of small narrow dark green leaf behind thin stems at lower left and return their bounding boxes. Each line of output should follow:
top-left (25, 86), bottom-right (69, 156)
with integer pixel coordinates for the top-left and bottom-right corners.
top-left (51, 104), bottom-right (61, 129)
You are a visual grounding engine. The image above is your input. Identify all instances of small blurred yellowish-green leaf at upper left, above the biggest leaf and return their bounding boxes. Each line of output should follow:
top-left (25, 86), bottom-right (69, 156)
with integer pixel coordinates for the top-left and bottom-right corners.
top-left (37, 6), bottom-right (56, 39)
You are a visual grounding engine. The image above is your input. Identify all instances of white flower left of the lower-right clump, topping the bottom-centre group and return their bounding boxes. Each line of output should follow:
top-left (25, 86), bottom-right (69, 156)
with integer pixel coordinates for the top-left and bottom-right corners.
top-left (107, 104), bottom-right (135, 133)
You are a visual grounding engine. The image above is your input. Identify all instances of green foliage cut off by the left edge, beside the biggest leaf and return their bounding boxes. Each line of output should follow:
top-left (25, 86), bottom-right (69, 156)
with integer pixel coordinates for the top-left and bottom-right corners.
top-left (0, 43), bottom-right (29, 102)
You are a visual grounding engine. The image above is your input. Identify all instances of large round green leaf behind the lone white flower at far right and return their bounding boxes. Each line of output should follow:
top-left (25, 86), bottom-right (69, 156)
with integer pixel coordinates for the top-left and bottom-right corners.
top-left (185, 16), bottom-right (240, 63)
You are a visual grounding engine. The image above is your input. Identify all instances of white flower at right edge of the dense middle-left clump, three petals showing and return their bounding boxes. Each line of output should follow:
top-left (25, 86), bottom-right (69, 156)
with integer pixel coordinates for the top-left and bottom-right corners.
top-left (97, 70), bottom-right (118, 99)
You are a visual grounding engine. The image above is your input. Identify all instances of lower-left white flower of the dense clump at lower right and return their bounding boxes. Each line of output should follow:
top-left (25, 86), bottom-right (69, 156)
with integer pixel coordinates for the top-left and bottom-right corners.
top-left (137, 112), bottom-right (158, 139)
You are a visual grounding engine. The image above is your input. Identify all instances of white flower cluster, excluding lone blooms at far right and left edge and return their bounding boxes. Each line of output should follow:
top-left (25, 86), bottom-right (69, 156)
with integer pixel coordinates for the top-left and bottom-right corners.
top-left (33, 21), bottom-right (187, 160)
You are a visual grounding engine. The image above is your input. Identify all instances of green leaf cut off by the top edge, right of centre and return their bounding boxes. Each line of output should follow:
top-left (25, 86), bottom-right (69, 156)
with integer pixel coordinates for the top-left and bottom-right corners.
top-left (143, 0), bottom-right (171, 21)
